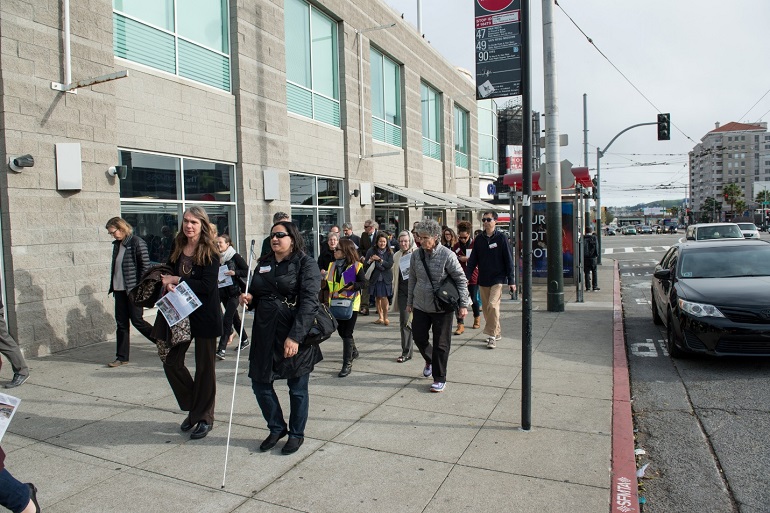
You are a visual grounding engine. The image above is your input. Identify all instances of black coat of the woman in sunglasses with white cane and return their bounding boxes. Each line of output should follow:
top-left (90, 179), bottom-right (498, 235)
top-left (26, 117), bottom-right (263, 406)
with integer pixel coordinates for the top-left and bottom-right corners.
top-left (244, 253), bottom-right (323, 383)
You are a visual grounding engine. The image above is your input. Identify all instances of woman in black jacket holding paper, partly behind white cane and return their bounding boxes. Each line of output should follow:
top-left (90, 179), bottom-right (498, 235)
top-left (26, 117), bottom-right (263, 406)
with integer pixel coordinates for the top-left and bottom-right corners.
top-left (217, 234), bottom-right (249, 360)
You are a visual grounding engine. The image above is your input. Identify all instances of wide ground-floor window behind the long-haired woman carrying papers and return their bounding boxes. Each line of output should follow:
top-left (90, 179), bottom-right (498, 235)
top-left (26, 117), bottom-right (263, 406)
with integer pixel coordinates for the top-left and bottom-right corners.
top-left (118, 150), bottom-right (238, 263)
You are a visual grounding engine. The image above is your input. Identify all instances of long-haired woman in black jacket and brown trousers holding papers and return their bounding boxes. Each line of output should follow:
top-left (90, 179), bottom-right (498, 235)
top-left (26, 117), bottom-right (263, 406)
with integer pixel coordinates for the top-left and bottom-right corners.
top-left (162, 206), bottom-right (222, 440)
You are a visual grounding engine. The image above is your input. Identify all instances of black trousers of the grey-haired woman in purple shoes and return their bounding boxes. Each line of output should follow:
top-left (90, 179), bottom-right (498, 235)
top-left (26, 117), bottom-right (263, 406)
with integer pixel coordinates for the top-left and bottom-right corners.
top-left (412, 309), bottom-right (454, 383)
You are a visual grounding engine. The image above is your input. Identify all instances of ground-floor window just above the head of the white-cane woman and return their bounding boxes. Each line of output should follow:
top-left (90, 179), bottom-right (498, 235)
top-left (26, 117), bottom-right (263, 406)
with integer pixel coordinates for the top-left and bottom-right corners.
top-left (289, 173), bottom-right (345, 258)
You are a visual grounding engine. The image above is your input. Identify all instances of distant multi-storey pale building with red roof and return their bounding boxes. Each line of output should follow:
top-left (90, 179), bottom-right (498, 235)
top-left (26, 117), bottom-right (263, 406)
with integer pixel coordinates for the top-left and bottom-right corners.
top-left (689, 122), bottom-right (770, 221)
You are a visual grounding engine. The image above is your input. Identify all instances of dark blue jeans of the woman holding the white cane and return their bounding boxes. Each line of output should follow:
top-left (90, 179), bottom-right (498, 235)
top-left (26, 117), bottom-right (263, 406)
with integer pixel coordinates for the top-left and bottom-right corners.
top-left (251, 373), bottom-right (310, 438)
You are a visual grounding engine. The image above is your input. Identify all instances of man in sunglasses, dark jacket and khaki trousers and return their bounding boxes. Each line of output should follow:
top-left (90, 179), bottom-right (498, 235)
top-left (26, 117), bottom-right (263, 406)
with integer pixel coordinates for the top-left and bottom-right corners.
top-left (465, 212), bottom-right (516, 349)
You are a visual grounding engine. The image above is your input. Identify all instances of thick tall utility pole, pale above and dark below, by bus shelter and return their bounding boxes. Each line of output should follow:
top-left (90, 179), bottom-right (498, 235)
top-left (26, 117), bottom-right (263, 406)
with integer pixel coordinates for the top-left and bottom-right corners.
top-left (543, 0), bottom-right (564, 312)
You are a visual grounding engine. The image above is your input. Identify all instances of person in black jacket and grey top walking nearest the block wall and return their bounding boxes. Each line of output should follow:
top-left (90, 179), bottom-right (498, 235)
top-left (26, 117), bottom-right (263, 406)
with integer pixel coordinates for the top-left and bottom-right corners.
top-left (105, 217), bottom-right (154, 367)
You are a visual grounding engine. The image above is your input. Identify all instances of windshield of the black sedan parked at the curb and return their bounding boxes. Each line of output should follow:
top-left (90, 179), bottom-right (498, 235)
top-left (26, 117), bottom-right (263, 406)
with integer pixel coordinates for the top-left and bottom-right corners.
top-left (678, 244), bottom-right (770, 278)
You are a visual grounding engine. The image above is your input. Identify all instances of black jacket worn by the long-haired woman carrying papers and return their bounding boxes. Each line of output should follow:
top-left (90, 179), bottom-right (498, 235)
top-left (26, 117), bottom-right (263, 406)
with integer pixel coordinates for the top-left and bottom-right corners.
top-left (168, 254), bottom-right (222, 338)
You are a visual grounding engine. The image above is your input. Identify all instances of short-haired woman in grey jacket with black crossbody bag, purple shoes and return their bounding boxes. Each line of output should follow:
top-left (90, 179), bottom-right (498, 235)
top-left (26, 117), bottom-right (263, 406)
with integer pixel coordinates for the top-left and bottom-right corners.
top-left (406, 220), bottom-right (471, 392)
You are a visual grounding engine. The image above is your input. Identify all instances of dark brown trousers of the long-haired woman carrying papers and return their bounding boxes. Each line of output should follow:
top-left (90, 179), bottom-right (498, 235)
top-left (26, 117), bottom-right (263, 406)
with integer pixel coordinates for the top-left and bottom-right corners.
top-left (163, 337), bottom-right (217, 425)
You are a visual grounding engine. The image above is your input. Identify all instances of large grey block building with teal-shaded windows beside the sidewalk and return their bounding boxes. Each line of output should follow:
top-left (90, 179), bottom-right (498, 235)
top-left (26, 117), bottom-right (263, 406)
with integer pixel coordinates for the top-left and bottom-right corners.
top-left (0, 0), bottom-right (495, 355)
